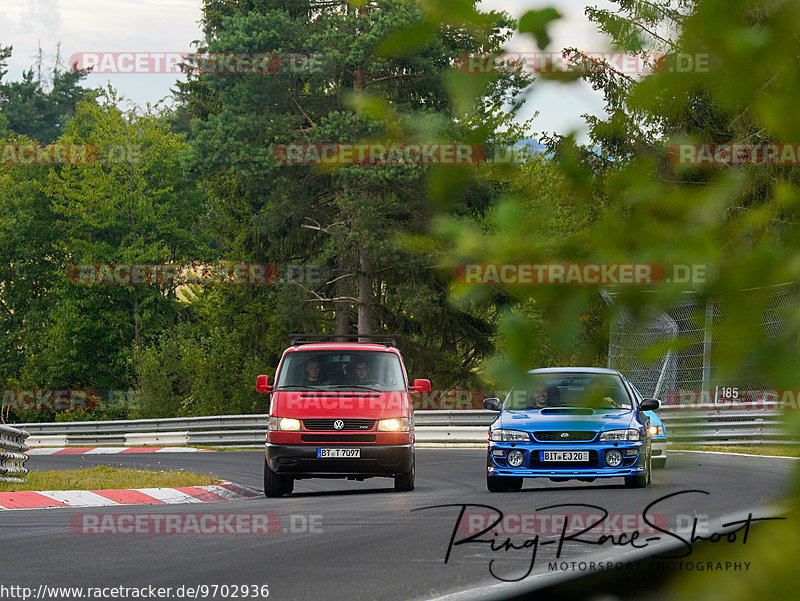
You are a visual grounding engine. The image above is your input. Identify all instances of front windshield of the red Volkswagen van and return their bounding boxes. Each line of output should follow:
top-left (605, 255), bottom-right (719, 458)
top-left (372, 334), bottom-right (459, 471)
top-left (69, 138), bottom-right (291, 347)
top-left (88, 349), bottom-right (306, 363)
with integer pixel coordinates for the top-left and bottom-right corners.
top-left (275, 351), bottom-right (405, 392)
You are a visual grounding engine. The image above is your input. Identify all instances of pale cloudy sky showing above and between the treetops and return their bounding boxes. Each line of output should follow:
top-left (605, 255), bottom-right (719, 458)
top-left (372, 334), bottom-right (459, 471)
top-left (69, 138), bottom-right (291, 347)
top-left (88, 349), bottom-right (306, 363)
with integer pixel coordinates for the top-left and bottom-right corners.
top-left (0, 0), bottom-right (610, 142)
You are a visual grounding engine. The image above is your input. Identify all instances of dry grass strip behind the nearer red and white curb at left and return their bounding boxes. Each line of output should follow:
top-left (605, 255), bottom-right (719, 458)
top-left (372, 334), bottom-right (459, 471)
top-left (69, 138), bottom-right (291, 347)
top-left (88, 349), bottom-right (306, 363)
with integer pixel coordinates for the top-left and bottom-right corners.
top-left (0, 465), bottom-right (220, 492)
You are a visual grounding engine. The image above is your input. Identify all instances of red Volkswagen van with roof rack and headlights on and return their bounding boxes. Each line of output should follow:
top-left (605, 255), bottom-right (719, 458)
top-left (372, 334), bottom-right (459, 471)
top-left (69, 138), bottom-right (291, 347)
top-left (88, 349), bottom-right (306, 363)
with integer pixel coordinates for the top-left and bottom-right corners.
top-left (256, 334), bottom-right (431, 497)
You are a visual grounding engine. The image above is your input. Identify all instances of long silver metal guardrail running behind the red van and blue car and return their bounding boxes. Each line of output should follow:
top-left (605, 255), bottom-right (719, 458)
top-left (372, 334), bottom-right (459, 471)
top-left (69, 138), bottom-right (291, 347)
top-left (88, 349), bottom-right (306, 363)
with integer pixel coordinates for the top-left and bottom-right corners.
top-left (17, 404), bottom-right (800, 447)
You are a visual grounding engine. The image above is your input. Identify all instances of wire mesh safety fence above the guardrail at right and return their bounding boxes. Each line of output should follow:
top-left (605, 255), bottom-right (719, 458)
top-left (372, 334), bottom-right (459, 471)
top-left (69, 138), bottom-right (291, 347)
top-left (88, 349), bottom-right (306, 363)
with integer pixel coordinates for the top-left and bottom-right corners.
top-left (604, 284), bottom-right (800, 405)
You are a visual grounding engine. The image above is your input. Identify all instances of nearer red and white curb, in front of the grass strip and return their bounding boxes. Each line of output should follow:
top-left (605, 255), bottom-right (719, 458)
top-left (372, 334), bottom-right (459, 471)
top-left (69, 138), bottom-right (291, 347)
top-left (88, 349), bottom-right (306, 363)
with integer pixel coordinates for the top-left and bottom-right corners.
top-left (0, 482), bottom-right (261, 511)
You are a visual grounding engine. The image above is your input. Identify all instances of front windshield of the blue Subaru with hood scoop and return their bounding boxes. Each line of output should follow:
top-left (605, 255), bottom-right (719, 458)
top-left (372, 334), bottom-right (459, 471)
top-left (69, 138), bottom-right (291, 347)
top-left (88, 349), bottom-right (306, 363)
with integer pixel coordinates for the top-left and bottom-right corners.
top-left (503, 372), bottom-right (632, 410)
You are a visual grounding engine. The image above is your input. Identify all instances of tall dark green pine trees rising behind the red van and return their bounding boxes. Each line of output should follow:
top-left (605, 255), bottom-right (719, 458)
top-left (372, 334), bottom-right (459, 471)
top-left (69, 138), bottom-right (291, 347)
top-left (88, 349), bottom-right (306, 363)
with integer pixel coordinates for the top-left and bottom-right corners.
top-left (157, 0), bottom-right (536, 410)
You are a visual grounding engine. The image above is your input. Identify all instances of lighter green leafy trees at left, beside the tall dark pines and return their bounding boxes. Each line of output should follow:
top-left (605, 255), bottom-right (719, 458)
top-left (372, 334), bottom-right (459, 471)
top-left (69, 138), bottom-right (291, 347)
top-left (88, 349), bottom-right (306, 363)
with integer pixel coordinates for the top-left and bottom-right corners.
top-left (0, 88), bottom-right (209, 404)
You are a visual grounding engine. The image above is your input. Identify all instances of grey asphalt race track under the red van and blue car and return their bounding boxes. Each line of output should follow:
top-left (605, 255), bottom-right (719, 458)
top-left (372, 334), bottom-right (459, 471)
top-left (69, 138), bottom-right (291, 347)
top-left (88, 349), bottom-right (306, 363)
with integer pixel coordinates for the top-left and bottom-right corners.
top-left (0, 449), bottom-right (798, 601)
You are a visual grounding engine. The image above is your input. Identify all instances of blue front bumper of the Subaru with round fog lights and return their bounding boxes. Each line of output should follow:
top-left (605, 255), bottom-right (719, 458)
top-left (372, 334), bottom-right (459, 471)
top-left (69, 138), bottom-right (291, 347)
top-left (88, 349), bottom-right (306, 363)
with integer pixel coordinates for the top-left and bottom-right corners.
top-left (487, 442), bottom-right (647, 478)
